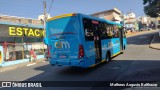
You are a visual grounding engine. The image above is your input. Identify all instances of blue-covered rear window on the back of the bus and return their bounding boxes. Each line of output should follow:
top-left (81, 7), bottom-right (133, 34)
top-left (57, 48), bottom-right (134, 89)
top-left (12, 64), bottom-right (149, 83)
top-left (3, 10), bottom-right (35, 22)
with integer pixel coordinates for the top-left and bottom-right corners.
top-left (47, 16), bottom-right (78, 37)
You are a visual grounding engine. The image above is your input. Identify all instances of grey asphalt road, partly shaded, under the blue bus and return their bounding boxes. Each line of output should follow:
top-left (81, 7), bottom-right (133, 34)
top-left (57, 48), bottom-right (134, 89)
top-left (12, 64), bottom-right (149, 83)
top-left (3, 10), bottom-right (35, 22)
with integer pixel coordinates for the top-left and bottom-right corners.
top-left (0, 32), bottom-right (160, 90)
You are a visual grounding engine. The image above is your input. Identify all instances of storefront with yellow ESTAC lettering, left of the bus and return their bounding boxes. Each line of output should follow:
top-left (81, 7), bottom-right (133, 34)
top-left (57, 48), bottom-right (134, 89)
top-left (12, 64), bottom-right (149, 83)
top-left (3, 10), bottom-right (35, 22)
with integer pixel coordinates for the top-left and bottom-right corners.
top-left (0, 24), bottom-right (46, 67)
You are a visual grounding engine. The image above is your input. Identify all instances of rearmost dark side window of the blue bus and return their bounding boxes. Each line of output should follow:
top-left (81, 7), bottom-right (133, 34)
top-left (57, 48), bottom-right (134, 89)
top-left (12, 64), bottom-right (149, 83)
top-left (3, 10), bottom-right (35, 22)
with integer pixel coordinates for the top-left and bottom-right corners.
top-left (83, 18), bottom-right (94, 41)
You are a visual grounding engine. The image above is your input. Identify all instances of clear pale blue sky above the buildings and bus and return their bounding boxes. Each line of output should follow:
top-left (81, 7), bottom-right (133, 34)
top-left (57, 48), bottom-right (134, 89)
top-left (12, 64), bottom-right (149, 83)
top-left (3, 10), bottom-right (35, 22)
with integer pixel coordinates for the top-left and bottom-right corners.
top-left (0, 0), bottom-right (145, 19)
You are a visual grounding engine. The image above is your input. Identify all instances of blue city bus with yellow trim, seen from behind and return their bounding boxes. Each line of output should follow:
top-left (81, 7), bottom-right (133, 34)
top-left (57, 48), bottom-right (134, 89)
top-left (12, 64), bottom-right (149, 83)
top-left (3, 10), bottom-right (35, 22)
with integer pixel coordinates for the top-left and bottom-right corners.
top-left (44, 13), bottom-right (127, 68)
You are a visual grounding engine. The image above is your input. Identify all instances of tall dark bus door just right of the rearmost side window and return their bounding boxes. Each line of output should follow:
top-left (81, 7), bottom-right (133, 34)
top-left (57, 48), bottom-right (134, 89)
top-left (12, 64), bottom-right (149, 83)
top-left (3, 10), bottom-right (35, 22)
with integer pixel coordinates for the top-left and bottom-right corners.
top-left (93, 25), bottom-right (102, 63)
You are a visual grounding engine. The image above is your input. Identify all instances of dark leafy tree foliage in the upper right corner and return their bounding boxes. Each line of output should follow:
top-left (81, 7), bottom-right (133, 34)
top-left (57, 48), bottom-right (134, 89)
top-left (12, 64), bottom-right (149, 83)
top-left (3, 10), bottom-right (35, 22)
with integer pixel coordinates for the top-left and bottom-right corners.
top-left (143, 0), bottom-right (160, 17)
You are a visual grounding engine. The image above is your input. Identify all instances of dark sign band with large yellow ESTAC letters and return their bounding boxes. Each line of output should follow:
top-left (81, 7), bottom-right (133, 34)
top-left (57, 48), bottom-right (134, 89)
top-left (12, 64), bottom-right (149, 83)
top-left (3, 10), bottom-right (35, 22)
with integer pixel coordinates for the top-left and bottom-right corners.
top-left (0, 24), bottom-right (44, 38)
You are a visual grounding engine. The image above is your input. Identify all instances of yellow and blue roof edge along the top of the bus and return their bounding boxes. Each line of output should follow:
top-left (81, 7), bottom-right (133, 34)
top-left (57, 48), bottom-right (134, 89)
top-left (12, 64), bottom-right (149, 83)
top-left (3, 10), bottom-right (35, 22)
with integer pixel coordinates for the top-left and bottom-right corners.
top-left (47, 13), bottom-right (122, 26)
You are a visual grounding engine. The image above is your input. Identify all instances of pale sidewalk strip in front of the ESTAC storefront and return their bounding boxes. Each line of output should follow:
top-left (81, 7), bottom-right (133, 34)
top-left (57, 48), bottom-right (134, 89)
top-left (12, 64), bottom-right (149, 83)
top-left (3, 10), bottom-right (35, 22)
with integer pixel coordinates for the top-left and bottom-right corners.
top-left (0, 58), bottom-right (46, 72)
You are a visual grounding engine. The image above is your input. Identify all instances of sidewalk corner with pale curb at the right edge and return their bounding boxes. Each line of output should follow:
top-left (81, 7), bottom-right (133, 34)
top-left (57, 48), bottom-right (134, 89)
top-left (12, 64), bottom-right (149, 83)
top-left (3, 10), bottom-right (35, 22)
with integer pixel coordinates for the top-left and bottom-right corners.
top-left (149, 33), bottom-right (160, 50)
